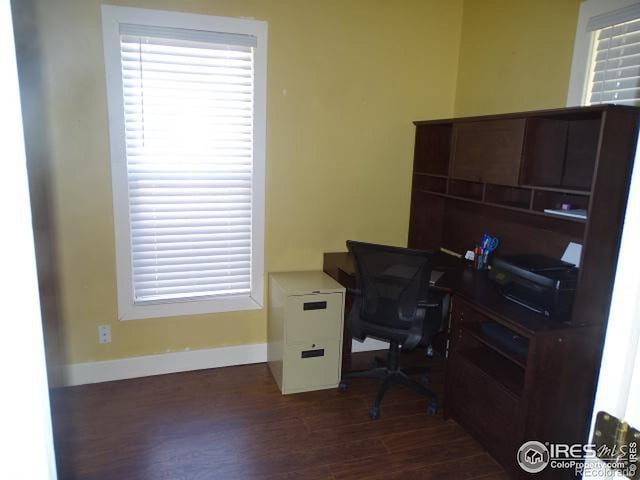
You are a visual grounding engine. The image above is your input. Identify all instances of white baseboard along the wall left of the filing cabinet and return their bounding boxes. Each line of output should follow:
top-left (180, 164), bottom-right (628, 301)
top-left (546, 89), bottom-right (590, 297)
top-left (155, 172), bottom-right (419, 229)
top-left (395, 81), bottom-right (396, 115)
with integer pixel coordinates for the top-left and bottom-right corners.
top-left (63, 343), bottom-right (267, 386)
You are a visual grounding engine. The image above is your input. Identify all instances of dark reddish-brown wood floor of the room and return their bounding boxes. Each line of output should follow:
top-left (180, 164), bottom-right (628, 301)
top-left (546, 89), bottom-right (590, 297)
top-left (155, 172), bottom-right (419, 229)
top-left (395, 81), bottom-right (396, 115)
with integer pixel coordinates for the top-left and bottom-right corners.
top-left (52, 353), bottom-right (507, 480)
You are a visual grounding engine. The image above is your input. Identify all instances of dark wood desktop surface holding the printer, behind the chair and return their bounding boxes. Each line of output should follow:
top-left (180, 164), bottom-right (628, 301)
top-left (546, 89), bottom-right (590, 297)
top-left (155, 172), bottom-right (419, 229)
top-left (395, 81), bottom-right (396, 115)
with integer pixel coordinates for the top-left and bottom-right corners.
top-left (324, 252), bottom-right (577, 337)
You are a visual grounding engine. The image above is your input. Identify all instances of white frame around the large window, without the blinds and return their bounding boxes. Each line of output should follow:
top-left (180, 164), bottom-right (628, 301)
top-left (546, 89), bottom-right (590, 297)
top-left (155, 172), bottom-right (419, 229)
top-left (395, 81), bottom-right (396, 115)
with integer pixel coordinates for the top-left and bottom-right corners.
top-left (102, 5), bottom-right (267, 320)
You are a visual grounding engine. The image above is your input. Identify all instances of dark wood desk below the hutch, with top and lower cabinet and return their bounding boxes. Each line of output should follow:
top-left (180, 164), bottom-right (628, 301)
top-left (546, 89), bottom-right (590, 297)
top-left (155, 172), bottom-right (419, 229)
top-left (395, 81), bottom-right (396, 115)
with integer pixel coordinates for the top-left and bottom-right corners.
top-left (324, 252), bottom-right (602, 478)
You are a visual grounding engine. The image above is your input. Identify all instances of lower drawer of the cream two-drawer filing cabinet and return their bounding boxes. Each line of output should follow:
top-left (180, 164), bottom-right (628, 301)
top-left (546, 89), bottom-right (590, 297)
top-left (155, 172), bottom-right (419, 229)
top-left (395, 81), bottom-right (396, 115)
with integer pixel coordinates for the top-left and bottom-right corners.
top-left (283, 340), bottom-right (341, 393)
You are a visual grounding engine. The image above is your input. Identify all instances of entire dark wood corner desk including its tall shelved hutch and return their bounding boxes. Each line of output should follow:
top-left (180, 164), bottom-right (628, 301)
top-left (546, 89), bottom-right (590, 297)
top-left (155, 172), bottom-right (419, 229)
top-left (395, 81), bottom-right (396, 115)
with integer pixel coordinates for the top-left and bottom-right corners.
top-left (325, 105), bottom-right (640, 479)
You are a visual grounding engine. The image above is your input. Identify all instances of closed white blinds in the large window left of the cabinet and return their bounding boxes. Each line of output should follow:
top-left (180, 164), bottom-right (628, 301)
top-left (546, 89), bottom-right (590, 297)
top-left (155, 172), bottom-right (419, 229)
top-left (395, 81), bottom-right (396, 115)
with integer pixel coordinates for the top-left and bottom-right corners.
top-left (120, 24), bottom-right (255, 304)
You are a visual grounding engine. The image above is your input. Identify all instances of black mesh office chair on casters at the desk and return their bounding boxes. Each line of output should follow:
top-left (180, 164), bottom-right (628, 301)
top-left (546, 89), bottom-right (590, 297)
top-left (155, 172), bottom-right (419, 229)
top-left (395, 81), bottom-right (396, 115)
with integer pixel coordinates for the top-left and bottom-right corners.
top-left (340, 240), bottom-right (448, 420)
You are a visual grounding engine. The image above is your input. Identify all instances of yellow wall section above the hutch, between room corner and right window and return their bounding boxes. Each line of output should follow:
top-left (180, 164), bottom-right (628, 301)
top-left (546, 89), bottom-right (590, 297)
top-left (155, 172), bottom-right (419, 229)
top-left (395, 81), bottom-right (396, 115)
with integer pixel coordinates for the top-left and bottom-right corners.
top-left (455, 0), bottom-right (580, 117)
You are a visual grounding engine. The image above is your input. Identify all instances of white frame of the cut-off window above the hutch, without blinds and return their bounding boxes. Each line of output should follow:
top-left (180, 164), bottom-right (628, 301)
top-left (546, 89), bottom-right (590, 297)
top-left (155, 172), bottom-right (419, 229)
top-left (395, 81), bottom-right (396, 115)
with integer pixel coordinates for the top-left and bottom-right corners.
top-left (567, 0), bottom-right (640, 107)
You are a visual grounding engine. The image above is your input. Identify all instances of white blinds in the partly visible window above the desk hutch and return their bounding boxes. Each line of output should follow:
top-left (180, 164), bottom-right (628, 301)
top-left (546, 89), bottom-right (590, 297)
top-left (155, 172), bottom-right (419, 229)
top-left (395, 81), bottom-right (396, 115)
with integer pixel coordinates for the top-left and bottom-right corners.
top-left (586, 7), bottom-right (640, 105)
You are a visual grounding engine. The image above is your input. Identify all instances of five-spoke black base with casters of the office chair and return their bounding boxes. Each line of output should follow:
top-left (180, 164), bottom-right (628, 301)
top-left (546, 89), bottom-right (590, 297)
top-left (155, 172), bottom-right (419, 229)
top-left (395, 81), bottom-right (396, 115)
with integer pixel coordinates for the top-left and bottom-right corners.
top-left (339, 342), bottom-right (438, 420)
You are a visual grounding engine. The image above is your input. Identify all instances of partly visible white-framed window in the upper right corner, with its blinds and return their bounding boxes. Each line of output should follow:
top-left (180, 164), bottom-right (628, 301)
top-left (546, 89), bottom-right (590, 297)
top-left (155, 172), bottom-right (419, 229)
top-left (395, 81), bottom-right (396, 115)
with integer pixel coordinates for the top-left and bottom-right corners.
top-left (567, 0), bottom-right (640, 105)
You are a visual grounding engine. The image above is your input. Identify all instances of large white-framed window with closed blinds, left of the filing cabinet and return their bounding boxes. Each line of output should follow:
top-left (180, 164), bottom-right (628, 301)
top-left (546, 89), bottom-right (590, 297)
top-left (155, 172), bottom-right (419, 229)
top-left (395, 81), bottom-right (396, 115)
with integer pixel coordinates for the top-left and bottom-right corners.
top-left (102, 5), bottom-right (267, 320)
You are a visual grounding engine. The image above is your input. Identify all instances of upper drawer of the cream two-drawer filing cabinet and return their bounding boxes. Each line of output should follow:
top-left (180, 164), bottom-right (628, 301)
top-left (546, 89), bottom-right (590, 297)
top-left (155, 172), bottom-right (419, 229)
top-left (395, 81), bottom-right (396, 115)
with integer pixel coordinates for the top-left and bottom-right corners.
top-left (285, 293), bottom-right (342, 345)
